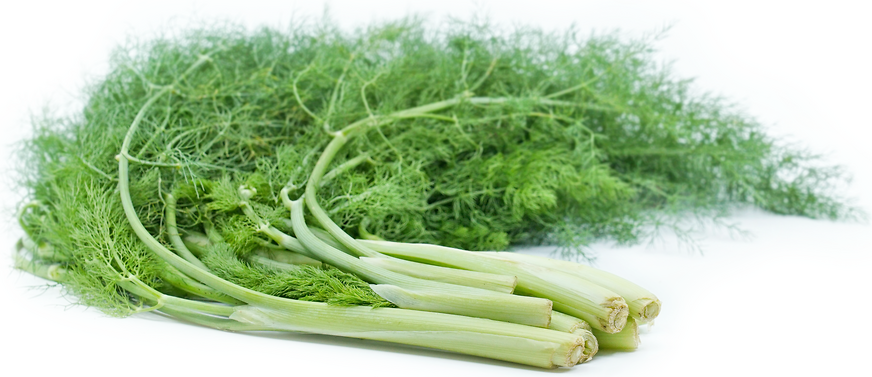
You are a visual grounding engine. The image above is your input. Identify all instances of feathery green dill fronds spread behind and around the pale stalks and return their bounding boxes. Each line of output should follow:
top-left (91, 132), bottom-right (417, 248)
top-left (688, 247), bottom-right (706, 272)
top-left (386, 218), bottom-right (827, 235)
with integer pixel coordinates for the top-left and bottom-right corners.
top-left (13, 18), bottom-right (856, 315)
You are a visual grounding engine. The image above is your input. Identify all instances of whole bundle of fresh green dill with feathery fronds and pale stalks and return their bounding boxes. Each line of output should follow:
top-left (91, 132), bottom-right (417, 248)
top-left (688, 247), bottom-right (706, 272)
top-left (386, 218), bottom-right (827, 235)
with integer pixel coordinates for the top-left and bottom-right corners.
top-left (16, 19), bottom-right (854, 367)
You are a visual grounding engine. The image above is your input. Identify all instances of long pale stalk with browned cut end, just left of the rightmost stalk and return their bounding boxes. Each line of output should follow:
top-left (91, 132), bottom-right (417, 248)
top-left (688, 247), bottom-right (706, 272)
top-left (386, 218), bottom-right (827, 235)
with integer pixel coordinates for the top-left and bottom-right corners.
top-left (358, 240), bottom-right (628, 333)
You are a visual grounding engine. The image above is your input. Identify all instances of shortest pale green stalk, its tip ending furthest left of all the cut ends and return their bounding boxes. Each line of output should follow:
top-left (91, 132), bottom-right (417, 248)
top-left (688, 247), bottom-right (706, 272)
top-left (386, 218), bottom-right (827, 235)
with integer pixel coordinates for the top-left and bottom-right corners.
top-left (360, 257), bottom-right (518, 293)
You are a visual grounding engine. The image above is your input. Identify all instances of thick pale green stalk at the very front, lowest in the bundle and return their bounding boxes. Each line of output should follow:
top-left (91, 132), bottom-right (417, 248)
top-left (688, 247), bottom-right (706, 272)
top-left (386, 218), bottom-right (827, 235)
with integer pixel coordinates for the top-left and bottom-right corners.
top-left (230, 303), bottom-right (584, 368)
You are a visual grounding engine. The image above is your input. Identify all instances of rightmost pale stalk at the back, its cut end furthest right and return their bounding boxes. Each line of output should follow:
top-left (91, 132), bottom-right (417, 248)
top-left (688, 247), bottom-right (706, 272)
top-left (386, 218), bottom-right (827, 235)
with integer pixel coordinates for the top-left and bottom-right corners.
top-left (488, 252), bottom-right (660, 324)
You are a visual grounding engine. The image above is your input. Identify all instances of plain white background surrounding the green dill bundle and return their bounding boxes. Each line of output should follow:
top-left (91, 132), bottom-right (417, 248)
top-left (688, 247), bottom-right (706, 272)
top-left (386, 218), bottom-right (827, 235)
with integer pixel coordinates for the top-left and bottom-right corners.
top-left (0, 0), bottom-right (872, 376)
